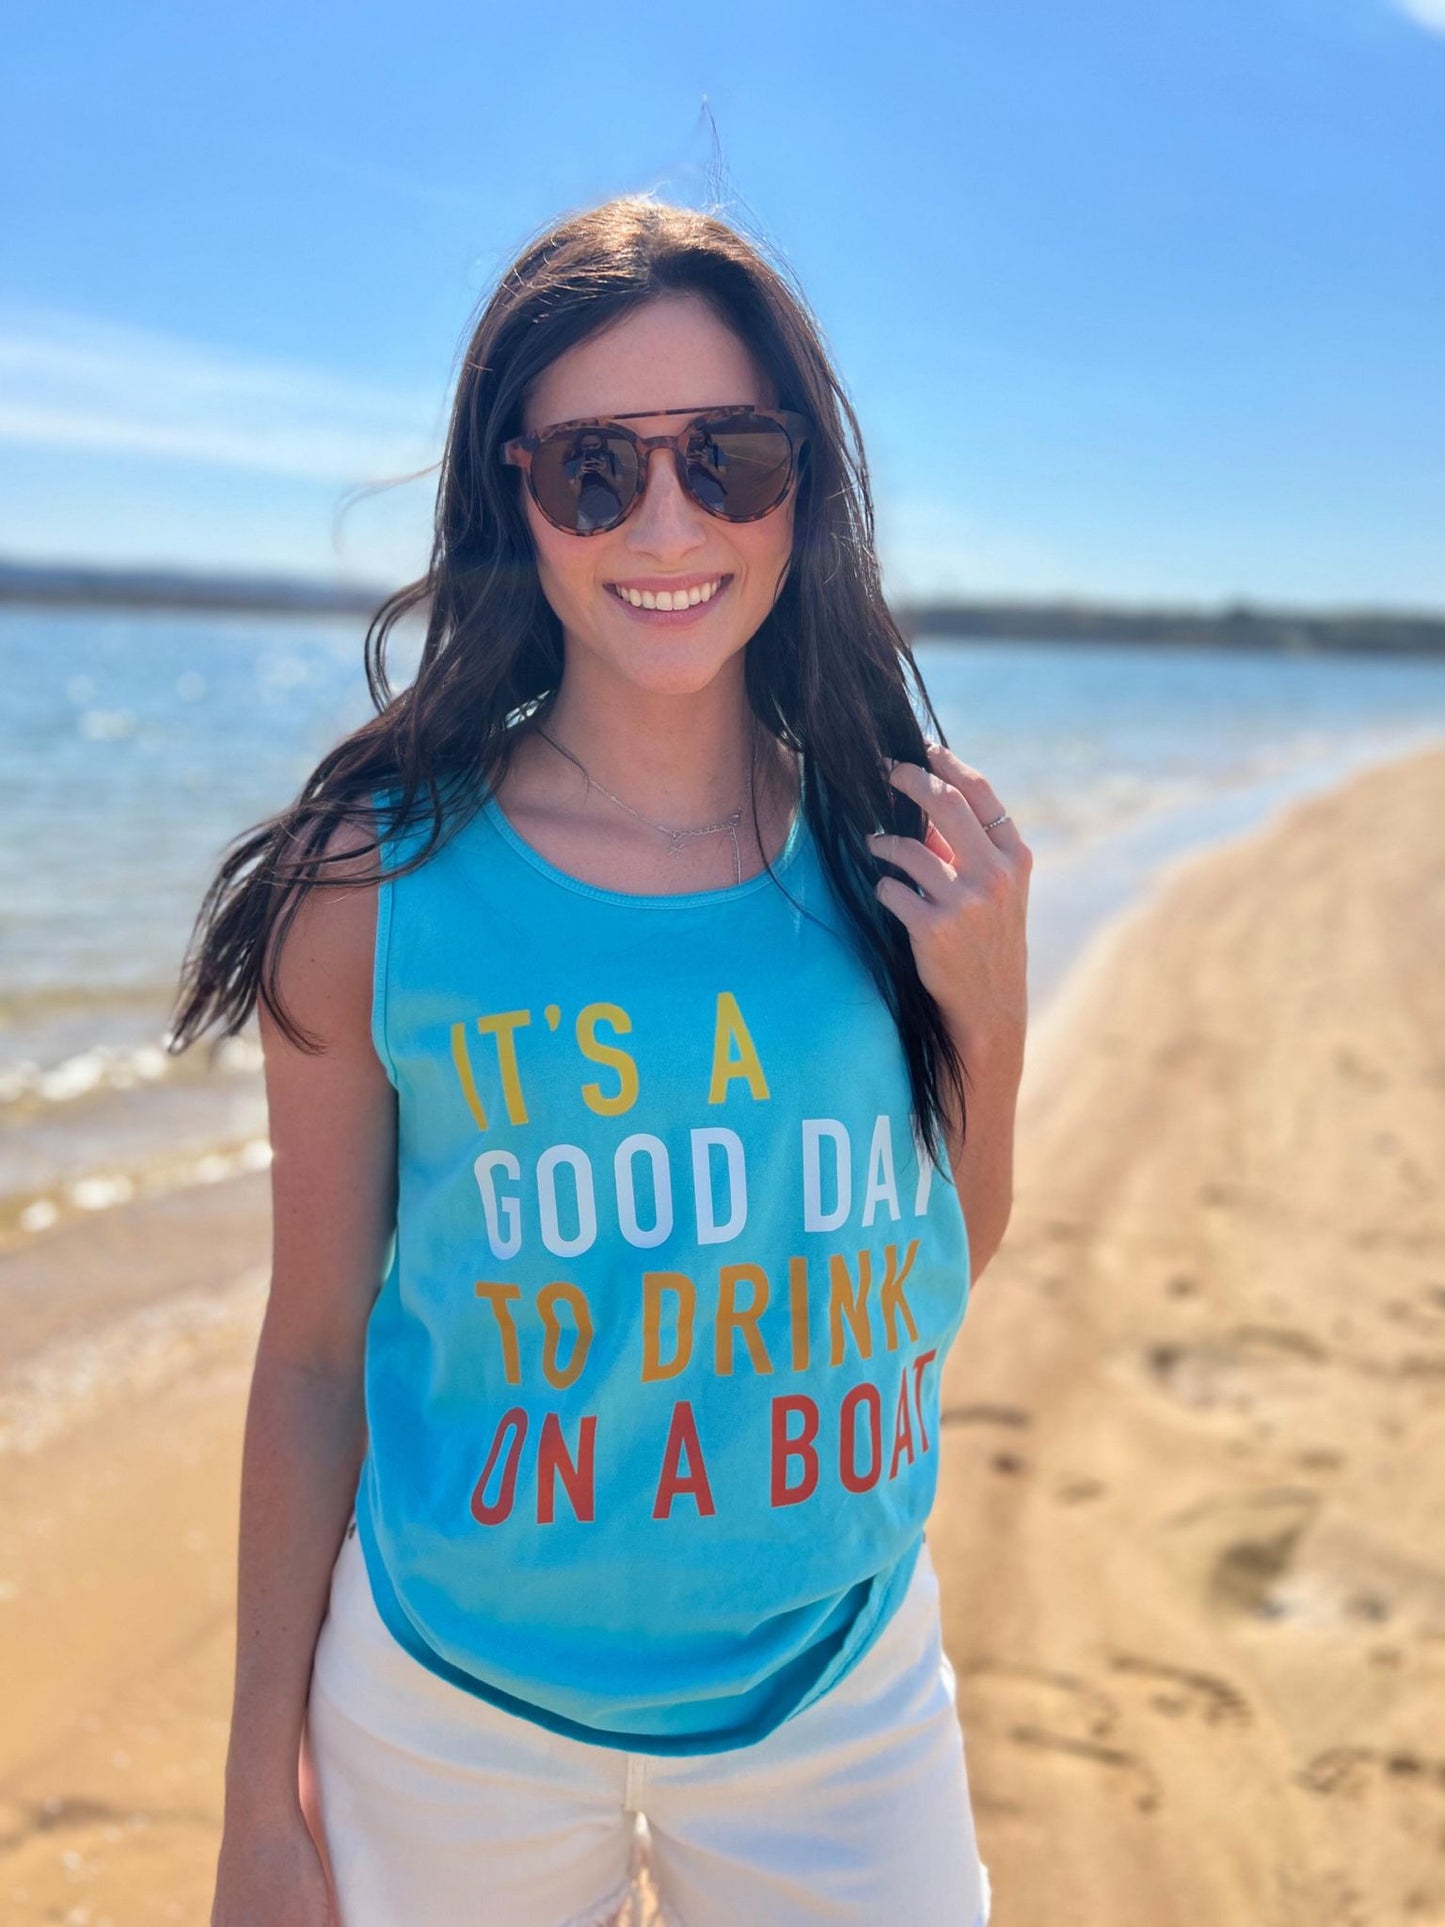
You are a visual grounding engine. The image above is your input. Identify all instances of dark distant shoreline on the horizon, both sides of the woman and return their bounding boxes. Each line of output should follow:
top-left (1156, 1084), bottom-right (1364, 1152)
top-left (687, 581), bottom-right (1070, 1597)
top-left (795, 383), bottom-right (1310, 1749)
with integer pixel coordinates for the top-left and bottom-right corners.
top-left (0, 561), bottom-right (1445, 657)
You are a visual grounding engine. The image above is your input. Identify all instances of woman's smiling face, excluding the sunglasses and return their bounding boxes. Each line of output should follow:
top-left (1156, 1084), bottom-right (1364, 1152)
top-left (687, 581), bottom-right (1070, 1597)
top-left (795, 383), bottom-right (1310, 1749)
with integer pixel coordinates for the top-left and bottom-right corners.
top-left (518, 295), bottom-right (796, 696)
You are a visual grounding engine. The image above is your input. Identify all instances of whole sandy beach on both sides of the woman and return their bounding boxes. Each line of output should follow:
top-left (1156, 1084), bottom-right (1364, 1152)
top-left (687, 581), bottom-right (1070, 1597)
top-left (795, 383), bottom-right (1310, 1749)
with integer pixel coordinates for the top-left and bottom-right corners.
top-left (0, 752), bottom-right (1445, 1927)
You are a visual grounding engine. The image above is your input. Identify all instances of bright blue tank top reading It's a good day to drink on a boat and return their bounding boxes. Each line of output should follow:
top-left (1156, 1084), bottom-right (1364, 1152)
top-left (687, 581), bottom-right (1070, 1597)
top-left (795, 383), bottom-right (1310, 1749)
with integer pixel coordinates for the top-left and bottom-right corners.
top-left (356, 759), bottom-right (969, 1754)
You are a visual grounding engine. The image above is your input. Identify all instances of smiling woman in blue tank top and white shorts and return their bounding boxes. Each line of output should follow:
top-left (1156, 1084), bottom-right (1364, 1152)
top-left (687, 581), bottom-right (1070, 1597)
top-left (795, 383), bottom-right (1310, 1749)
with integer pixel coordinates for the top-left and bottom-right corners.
top-left (183, 198), bottom-right (1031, 1927)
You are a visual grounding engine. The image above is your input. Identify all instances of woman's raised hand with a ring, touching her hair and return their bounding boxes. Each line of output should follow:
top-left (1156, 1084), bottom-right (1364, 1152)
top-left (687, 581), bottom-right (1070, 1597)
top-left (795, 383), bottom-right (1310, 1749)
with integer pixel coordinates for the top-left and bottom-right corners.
top-left (869, 744), bottom-right (1033, 1062)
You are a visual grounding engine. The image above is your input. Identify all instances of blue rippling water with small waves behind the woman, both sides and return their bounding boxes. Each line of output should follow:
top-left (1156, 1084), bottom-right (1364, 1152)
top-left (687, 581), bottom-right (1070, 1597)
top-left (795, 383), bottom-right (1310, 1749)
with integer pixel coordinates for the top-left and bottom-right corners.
top-left (0, 609), bottom-right (1445, 1249)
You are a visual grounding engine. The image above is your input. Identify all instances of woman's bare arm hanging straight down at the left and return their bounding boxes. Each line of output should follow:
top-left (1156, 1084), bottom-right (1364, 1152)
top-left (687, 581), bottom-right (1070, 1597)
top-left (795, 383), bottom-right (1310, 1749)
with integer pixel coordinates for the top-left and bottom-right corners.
top-left (214, 831), bottom-right (397, 1921)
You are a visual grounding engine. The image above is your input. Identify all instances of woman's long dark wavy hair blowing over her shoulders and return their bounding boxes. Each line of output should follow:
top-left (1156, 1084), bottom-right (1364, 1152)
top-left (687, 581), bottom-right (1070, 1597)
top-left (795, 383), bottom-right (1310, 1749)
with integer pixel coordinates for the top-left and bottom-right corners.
top-left (168, 195), bottom-right (967, 1160)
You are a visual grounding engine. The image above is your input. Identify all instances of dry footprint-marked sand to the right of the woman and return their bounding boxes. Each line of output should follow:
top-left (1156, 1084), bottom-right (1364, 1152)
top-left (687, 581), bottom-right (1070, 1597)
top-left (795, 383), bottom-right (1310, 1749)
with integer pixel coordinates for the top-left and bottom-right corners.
top-left (931, 739), bottom-right (1445, 1927)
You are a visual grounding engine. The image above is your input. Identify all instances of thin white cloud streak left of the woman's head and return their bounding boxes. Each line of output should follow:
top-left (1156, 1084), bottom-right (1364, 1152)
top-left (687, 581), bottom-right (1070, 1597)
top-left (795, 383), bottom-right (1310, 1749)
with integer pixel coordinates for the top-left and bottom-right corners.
top-left (0, 310), bottom-right (441, 486)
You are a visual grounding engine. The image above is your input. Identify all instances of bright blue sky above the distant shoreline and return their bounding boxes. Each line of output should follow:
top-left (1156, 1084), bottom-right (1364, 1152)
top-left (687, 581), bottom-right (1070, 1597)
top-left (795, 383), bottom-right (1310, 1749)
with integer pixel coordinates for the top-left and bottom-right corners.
top-left (0, 0), bottom-right (1445, 607)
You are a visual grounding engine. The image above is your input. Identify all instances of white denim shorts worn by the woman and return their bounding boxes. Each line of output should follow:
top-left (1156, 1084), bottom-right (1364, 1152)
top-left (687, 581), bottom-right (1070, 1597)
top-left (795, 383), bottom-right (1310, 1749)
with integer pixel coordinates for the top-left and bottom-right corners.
top-left (306, 1528), bottom-right (988, 1927)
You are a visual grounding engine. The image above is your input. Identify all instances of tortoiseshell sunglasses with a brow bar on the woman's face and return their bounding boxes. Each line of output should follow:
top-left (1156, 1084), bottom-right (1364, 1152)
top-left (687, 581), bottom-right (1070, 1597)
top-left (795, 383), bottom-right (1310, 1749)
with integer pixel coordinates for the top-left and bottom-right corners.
top-left (501, 403), bottom-right (811, 536)
